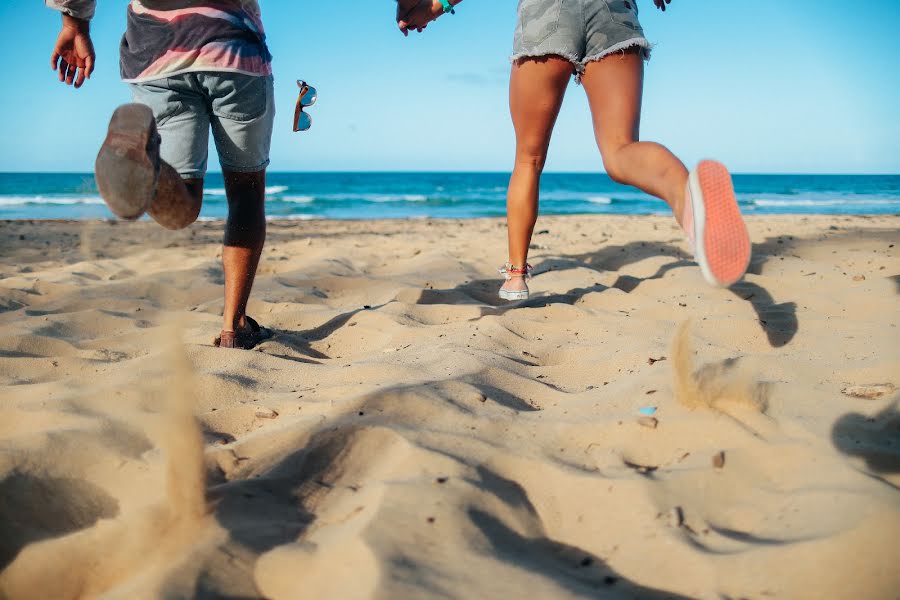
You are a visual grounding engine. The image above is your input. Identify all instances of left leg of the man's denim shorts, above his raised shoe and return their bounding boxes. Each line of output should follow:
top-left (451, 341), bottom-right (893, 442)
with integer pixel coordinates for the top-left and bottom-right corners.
top-left (131, 76), bottom-right (209, 179)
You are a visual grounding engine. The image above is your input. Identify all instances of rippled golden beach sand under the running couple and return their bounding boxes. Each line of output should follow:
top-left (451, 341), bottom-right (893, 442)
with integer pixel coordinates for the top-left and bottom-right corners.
top-left (0, 217), bottom-right (900, 599)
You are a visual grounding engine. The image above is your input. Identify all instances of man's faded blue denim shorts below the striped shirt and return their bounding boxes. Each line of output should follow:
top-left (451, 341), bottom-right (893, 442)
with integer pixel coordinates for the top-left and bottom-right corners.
top-left (130, 72), bottom-right (275, 179)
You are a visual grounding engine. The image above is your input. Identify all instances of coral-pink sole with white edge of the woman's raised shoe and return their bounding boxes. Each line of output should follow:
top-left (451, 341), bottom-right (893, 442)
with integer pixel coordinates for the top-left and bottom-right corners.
top-left (690, 160), bottom-right (751, 287)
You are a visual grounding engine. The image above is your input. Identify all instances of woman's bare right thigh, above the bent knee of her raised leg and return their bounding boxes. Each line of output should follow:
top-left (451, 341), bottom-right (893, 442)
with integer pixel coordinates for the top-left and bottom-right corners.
top-left (581, 48), bottom-right (644, 153)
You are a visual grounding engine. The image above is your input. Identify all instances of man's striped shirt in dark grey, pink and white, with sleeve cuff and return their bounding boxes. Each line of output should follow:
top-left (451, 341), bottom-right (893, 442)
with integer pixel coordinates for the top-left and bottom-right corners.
top-left (45, 0), bottom-right (272, 83)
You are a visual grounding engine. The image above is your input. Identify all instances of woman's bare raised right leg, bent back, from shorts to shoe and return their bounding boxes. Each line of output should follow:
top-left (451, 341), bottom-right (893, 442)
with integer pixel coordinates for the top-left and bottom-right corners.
top-left (581, 48), bottom-right (688, 223)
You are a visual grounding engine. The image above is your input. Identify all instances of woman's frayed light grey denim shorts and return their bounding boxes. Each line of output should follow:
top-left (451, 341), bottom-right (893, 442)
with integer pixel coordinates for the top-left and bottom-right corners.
top-left (511, 0), bottom-right (651, 75)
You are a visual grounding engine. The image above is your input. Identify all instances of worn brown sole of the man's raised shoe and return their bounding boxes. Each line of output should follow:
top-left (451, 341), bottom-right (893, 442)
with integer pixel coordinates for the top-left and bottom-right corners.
top-left (94, 104), bottom-right (158, 220)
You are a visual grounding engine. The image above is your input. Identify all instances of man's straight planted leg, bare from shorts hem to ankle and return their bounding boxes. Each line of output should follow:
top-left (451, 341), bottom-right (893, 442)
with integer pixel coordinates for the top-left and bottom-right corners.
top-left (222, 171), bottom-right (266, 331)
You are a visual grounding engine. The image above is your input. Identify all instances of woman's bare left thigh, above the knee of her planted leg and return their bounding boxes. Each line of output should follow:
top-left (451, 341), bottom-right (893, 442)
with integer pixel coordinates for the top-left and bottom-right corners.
top-left (509, 56), bottom-right (572, 158)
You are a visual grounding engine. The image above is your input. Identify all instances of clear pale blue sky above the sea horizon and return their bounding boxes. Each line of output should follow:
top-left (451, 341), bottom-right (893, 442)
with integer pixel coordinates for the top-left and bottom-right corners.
top-left (0, 0), bottom-right (900, 173)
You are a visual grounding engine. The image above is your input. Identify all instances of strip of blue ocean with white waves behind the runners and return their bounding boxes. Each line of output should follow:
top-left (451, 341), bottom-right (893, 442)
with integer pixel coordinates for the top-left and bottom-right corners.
top-left (0, 173), bottom-right (900, 219)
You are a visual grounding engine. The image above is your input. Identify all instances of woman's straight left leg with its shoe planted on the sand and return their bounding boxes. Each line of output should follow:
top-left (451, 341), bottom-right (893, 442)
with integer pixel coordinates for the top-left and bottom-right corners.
top-left (501, 56), bottom-right (573, 291)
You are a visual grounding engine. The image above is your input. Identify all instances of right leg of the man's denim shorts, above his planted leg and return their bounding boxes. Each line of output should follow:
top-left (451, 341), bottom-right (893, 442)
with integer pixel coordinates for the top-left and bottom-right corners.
top-left (204, 73), bottom-right (275, 173)
